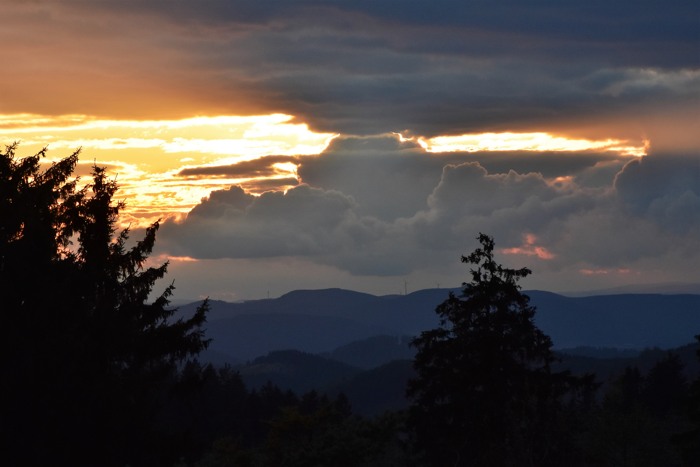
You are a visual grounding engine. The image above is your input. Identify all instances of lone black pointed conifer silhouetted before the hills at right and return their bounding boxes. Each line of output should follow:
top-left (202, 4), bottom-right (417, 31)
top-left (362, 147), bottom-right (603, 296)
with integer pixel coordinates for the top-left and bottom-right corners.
top-left (408, 234), bottom-right (578, 467)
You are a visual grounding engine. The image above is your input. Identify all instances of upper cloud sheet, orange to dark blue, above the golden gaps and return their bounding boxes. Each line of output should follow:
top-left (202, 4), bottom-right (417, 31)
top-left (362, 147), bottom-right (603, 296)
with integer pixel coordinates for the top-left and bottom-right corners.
top-left (0, 0), bottom-right (700, 143)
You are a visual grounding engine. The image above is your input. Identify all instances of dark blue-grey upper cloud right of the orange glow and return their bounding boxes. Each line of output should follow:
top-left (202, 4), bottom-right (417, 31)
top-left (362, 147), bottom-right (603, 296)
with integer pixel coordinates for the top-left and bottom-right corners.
top-left (41, 0), bottom-right (700, 137)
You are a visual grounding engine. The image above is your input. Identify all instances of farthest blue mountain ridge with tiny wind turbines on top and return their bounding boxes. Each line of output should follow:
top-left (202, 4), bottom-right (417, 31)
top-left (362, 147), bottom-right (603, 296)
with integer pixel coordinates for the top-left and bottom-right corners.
top-left (179, 289), bottom-right (700, 368)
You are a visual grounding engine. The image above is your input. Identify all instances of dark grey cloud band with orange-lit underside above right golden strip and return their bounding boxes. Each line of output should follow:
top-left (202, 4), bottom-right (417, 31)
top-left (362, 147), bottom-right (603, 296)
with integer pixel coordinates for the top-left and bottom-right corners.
top-left (266, 63), bottom-right (700, 138)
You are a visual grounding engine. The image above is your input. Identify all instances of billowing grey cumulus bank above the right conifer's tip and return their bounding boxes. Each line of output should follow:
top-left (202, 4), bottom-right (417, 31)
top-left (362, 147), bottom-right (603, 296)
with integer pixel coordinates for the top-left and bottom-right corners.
top-left (409, 155), bottom-right (700, 270)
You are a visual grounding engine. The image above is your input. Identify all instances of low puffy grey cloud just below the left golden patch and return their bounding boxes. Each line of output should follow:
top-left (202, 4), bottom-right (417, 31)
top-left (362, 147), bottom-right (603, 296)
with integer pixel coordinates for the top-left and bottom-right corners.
top-left (162, 185), bottom-right (378, 258)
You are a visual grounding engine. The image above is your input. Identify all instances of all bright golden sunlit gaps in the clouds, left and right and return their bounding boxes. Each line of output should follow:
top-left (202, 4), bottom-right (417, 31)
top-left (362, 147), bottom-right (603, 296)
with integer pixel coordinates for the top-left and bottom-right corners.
top-left (0, 114), bottom-right (648, 230)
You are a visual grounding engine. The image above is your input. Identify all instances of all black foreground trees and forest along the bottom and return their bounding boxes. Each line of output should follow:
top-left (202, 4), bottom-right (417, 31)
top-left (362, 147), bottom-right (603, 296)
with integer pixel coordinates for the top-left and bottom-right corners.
top-left (0, 146), bottom-right (700, 466)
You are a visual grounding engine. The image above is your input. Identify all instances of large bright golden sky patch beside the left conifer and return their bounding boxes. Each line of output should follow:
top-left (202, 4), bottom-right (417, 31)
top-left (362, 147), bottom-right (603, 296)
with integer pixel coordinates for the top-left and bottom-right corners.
top-left (0, 114), bottom-right (337, 226)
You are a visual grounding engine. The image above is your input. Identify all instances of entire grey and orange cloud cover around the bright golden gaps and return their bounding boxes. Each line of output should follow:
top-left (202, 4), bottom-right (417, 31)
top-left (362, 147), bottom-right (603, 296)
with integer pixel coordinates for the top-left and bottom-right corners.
top-left (0, 0), bottom-right (700, 288)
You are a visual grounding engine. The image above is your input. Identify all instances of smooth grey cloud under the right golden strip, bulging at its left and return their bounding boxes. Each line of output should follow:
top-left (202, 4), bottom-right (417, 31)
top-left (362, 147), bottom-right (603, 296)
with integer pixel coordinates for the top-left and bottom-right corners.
top-left (298, 135), bottom-right (627, 220)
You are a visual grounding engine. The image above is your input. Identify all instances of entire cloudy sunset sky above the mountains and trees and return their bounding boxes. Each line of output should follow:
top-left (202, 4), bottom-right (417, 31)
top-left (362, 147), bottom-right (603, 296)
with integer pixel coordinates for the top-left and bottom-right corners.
top-left (0, 0), bottom-right (700, 300)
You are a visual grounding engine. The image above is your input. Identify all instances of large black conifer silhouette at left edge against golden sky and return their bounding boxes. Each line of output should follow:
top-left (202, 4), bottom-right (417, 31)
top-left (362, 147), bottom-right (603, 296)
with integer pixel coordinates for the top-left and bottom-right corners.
top-left (0, 145), bottom-right (207, 465)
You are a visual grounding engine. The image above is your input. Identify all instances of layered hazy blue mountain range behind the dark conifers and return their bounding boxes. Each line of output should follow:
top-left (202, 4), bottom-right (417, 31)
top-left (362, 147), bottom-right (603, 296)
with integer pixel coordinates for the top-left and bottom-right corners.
top-left (172, 289), bottom-right (700, 415)
